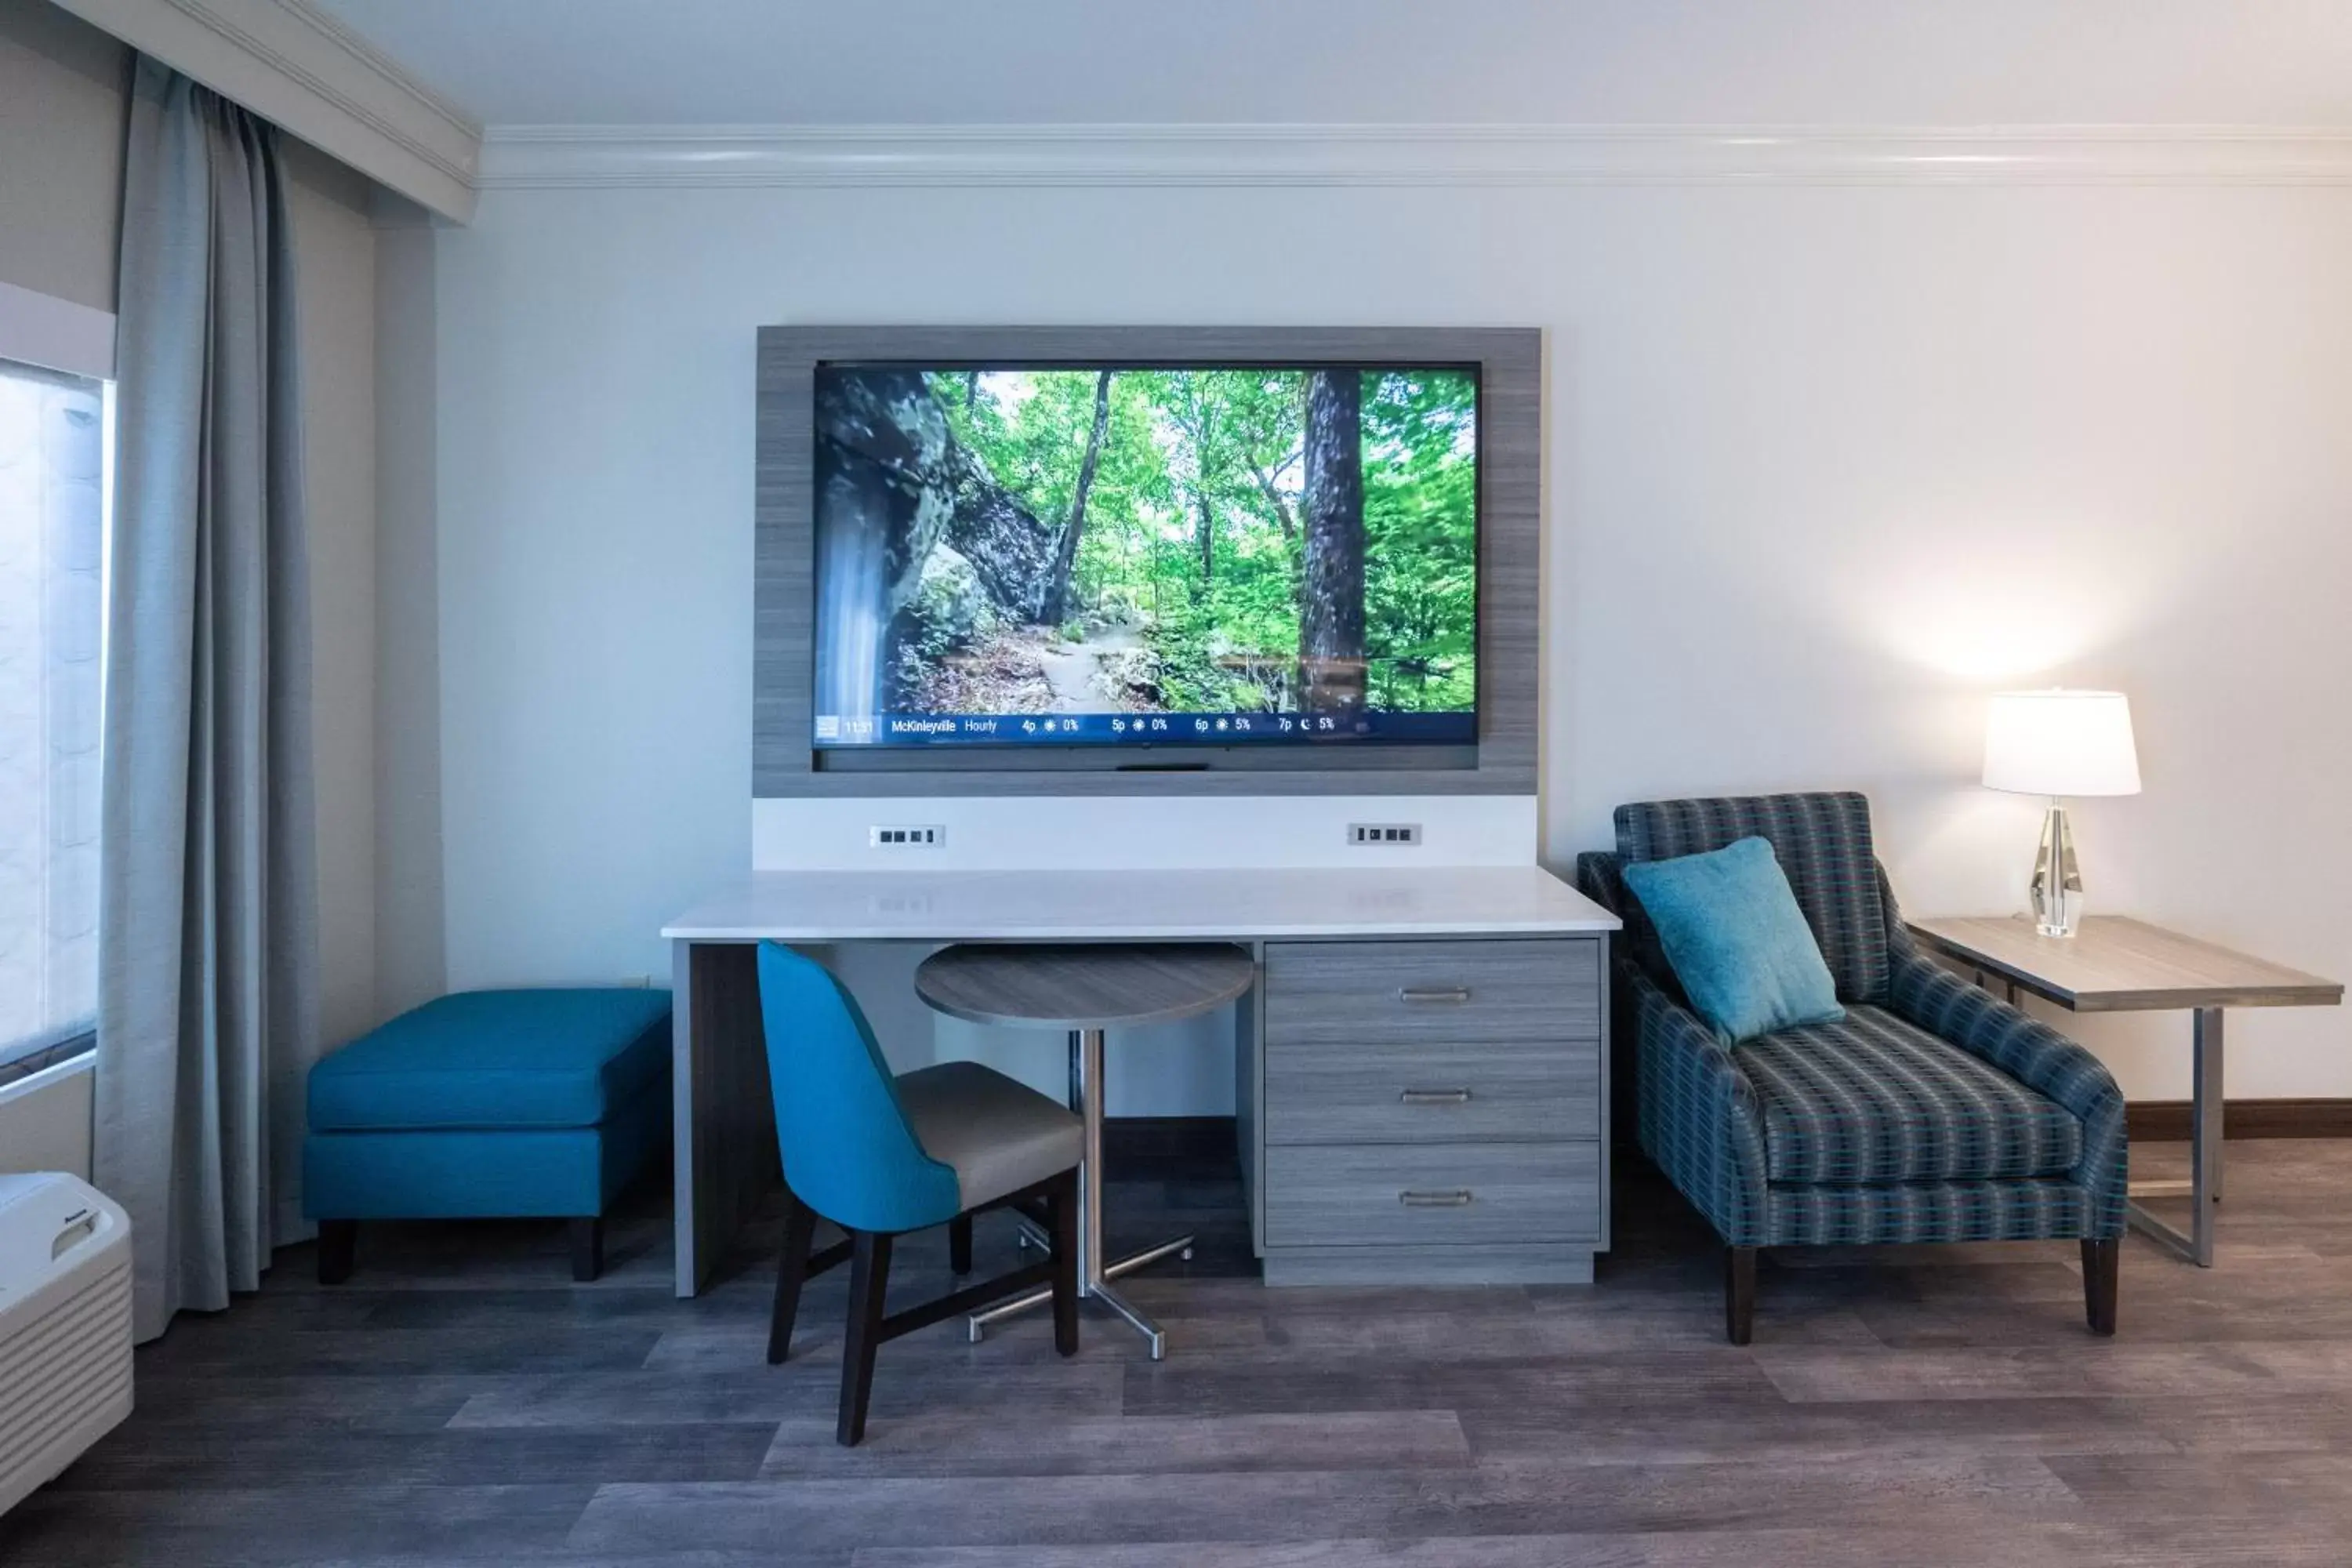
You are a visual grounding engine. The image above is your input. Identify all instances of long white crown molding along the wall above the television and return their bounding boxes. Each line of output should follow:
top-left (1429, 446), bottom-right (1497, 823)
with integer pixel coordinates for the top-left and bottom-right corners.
top-left (477, 125), bottom-right (2352, 191)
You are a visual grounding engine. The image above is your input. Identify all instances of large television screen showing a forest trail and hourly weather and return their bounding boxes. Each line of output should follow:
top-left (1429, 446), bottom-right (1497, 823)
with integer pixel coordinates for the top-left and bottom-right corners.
top-left (811, 365), bottom-right (1479, 750)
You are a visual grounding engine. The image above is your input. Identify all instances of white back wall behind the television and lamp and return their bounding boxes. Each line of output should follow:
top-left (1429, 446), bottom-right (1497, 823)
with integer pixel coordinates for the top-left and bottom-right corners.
top-left (409, 175), bottom-right (2352, 1095)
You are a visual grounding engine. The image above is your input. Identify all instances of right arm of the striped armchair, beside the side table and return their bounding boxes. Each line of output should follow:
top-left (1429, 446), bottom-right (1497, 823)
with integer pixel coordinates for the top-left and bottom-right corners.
top-left (1889, 945), bottom-right (2129, 1239)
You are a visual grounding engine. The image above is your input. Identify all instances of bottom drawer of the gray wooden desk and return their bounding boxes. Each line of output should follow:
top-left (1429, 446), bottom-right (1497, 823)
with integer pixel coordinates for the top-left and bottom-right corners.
top-left (1265, 1142), bottom-right (1599, 1246)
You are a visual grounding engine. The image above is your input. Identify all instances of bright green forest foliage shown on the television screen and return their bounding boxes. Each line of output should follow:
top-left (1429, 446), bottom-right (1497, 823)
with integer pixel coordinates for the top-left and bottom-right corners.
top-left (927, 369), bottom-right (1477, 713)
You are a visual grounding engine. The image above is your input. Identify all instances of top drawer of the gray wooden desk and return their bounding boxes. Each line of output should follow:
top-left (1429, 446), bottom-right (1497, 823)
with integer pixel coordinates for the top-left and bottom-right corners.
top-left (1265, 940), bottom-right (1602, 1046)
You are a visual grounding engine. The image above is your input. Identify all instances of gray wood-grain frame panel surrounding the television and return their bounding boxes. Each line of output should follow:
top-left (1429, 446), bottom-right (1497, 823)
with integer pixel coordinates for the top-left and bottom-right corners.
top-left (753, 327), bottom-right (1543, 799)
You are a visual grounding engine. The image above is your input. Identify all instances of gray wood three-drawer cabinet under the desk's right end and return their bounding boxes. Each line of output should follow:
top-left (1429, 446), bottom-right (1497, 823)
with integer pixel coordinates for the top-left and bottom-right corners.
top-left (1235, 935), bottom-right (1609, 1286)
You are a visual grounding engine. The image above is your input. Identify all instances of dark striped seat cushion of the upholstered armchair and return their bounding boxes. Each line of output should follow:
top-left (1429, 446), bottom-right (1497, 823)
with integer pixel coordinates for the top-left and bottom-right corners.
top-left (1731, 1006), bottom-right (2082, 1182)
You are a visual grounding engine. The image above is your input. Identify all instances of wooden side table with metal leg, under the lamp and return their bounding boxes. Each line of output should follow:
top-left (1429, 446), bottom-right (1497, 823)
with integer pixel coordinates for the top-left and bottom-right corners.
top-left (1910, 914), bottom-right (2345, 1269)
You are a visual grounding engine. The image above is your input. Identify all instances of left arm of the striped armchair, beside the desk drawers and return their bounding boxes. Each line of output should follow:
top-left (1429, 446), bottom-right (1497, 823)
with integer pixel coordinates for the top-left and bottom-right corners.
top-left (1618, 959), bottom-right (1769, 1246)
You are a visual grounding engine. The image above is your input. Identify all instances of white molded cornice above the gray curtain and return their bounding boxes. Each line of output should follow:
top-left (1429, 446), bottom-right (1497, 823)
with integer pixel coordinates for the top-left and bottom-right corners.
top-left (56, 0), bottom-right (482, 223)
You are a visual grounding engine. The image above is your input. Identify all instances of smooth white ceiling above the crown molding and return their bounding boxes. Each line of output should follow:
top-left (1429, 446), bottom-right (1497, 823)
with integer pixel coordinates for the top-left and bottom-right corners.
top-left (313, 0), bottom-right (2352, 127)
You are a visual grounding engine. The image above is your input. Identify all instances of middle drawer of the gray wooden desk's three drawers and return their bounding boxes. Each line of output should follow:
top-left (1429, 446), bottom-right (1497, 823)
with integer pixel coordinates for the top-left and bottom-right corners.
top-left (1265, 1039), bottom-right (1602, 1142)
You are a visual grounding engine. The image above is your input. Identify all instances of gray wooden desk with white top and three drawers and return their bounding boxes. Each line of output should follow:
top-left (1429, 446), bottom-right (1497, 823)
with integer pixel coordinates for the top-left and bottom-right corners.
top-left (663, 865), bottom-right (1618, 1295)
